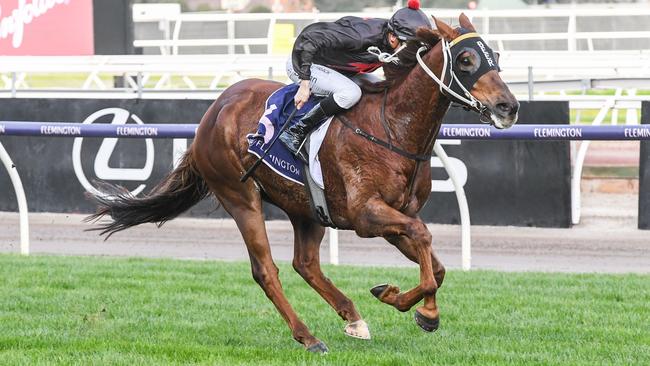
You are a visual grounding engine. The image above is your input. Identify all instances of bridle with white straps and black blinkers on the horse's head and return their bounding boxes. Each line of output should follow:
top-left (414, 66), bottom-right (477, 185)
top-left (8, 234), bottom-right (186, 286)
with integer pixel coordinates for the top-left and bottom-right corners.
top-left (415, 32), bottom-right (499, 125)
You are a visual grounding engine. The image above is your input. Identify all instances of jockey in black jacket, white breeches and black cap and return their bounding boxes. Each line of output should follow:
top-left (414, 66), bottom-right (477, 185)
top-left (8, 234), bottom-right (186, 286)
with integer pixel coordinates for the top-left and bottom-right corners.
top-left (280, 0), bottom-right (431, 155)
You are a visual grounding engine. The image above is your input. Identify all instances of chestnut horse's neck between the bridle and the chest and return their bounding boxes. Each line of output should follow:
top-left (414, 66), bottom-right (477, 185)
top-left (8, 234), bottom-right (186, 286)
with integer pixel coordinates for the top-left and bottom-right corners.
top-left (386, 44), bottom-right (450, 154)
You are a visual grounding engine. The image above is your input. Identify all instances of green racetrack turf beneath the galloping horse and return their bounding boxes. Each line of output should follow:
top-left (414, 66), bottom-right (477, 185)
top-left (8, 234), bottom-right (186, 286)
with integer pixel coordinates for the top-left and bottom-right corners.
top-left (0, 255), bottom-right (650, 365)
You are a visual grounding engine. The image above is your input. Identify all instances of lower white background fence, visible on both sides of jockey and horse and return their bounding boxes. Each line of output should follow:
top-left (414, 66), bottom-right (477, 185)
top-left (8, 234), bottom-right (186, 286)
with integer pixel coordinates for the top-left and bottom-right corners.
top-left (0, 50), bottom-right (650, 96)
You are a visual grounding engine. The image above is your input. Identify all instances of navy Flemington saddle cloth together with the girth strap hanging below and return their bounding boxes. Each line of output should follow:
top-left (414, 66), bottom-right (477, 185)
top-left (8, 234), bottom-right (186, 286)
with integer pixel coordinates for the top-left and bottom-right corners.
top-left (247, 84), bottom-right (335, 227)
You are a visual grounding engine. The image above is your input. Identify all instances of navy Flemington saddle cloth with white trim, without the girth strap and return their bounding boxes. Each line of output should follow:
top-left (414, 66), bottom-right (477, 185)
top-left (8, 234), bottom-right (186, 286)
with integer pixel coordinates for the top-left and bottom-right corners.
top-left (246, 84), bottom-right (332, 188)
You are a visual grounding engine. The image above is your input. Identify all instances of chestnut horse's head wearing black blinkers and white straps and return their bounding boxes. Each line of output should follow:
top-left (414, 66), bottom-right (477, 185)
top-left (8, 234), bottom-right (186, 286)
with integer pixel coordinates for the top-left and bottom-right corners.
top-left (421, 14), bottom-right (519, 128)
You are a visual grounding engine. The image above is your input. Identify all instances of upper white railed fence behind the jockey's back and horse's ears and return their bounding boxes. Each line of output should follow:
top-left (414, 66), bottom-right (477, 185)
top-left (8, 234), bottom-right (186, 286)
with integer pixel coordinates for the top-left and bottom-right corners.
top-left (134, 4), bottom-right (650, 55)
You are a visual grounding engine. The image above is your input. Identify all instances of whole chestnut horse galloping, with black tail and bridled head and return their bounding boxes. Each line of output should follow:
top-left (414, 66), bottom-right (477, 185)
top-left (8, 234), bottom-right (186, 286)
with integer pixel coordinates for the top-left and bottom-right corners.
top-left (89, 14), bottom-right (519, 352)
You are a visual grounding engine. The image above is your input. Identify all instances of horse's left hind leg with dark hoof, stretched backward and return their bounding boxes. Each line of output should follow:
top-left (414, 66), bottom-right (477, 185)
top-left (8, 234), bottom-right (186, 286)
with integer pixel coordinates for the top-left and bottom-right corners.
top-left (210, 181), bottom-right (327, 352)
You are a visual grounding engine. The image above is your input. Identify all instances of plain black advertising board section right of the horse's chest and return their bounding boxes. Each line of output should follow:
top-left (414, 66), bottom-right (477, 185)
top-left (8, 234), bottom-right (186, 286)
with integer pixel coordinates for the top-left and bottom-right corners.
top-left (422, 102), bottom-right (571, 227)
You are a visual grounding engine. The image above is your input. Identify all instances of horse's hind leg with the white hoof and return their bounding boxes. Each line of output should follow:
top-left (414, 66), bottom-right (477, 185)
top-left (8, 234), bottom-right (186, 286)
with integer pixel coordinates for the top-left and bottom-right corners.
top-left (291, 218), bottom-right (370, 339)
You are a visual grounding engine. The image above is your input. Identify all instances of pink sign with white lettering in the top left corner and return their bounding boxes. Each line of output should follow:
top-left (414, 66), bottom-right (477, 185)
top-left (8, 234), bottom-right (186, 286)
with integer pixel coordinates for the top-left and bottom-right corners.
top-left (0, 0), bottom-right (94, 56)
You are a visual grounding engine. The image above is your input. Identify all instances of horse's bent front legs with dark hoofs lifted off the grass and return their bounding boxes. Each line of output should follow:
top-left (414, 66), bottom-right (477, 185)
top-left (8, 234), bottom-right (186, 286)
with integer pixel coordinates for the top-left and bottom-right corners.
top-left (355, 199), bottom-right (444, 331)
